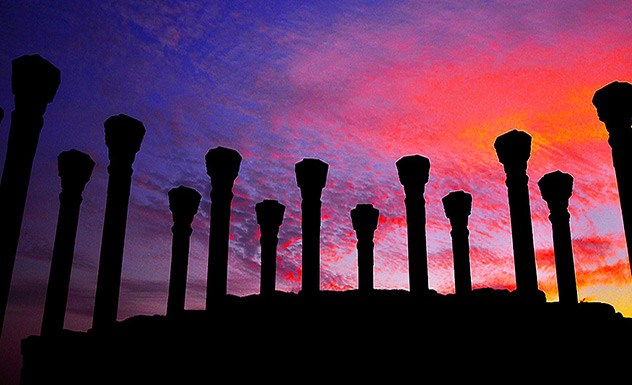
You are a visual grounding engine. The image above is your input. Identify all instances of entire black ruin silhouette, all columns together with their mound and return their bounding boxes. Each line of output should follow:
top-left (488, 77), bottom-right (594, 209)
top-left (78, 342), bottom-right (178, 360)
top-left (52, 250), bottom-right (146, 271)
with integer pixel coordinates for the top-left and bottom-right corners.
top-left (0, 55), bottom-right (632, 385)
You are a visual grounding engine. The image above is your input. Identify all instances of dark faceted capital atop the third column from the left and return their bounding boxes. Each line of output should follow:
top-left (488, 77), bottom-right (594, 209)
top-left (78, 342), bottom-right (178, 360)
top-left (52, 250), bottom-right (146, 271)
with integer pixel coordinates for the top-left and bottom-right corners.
top-left (103, 114), bottom-right (145, 166)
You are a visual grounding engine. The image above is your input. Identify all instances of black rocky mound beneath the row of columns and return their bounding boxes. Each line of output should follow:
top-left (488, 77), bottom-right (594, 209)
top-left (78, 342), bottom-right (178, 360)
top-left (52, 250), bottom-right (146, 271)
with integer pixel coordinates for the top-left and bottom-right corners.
top-left (22, 289), bottom-right (632, 385)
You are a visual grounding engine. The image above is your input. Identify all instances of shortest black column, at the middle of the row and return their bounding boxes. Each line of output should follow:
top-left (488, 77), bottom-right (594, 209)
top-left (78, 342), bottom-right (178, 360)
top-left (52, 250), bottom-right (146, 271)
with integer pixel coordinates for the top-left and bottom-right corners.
top-left (351, 204), bottom-right (380, 293)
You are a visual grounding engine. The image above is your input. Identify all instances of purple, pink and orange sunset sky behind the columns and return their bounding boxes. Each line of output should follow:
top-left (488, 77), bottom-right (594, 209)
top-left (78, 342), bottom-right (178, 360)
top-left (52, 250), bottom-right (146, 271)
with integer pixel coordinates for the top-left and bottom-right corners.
top-left (0, 0), bottom-right (632, 383)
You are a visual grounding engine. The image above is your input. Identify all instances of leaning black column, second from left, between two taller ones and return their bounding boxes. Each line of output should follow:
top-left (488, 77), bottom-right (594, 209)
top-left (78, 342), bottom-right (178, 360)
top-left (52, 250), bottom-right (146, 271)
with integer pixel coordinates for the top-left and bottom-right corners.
top-left (41, 150), bottom-right (95, 336)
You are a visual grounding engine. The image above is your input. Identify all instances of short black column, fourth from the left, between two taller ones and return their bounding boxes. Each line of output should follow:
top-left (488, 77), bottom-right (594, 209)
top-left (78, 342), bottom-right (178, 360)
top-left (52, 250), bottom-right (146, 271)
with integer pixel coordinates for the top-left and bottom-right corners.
top-left (167, 186), bottom-right (202, 316)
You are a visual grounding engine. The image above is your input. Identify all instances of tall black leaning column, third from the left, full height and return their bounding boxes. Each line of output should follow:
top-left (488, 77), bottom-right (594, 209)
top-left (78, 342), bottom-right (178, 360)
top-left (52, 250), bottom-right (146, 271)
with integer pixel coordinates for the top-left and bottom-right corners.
top-left (92, 114), bottom-right (145, 330)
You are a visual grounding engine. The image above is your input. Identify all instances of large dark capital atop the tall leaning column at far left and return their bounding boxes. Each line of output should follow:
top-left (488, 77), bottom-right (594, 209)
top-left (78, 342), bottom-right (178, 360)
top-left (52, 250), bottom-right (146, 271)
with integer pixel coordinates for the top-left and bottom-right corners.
top-left (11, 54), bottom-right (61, 107)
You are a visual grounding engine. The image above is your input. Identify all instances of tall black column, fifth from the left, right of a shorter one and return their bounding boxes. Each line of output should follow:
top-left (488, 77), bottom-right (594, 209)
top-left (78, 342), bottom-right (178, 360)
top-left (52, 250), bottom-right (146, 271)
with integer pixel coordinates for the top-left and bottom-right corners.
top-left (206, 147), bottom-right (241, 309)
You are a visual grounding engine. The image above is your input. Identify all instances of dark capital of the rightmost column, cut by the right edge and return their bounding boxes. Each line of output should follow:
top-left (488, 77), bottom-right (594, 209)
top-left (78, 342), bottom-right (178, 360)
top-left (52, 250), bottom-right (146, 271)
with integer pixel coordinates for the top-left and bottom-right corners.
top-left (592, 81), bottom-right (632, 130)
